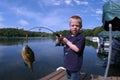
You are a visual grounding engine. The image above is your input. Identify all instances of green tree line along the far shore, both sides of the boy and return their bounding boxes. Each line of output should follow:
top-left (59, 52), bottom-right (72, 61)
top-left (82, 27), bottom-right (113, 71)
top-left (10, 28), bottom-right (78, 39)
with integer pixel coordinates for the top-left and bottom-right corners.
top-left (0, 26), bottom-right (104, 37)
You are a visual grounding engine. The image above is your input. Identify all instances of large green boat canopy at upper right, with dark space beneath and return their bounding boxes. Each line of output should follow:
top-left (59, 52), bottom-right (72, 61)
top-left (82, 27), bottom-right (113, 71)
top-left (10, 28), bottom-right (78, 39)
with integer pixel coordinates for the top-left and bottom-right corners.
top-left (102, 0), bottom-right (120, 31)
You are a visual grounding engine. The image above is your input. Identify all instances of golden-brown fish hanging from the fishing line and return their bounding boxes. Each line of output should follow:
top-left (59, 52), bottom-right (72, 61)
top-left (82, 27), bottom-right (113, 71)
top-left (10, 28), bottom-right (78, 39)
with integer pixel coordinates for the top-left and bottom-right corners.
top-left (22, 44), bottom-right (35, 72)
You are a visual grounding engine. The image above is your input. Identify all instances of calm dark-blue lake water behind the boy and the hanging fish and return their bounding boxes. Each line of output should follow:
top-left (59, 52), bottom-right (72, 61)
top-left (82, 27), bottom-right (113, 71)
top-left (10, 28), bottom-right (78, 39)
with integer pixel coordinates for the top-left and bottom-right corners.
top-left (0, 37), bottom-right (105, 80)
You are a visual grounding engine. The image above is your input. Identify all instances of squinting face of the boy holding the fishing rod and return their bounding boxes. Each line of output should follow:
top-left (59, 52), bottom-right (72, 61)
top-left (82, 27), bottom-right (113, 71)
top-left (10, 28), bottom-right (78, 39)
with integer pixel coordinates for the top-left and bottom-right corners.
top-left (70, 19), bottom-right (81, 35)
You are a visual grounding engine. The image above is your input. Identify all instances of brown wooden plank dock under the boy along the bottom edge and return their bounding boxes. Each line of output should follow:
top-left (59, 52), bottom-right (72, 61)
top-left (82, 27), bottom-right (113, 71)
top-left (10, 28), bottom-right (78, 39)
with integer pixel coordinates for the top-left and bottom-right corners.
top-left (39, 69), bottom-right (120, 80)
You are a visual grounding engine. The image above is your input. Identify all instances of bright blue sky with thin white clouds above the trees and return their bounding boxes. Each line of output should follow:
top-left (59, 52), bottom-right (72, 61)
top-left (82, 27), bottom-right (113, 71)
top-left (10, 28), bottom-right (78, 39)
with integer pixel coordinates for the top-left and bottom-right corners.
top-left (0, 0), bottom-right (119, 31)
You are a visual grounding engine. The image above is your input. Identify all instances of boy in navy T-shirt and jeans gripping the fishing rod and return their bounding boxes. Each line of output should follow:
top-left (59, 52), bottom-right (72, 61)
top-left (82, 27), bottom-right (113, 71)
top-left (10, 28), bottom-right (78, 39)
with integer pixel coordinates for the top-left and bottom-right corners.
top-left (56, 16), bottom-right (85, 80)
